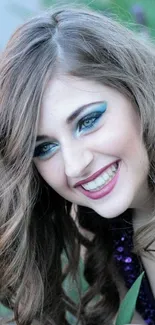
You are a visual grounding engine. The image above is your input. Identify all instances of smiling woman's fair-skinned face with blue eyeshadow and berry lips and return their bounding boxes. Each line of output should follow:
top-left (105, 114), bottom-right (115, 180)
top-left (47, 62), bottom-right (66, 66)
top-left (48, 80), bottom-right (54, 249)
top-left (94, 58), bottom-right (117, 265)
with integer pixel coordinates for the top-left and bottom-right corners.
top-left (34, 77), bottom-right (149, 218)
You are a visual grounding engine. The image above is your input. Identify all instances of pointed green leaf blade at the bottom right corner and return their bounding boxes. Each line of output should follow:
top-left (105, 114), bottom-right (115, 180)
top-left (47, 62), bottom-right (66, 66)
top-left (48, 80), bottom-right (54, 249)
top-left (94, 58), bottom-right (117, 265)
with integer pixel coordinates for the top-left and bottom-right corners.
top-left (116, 272), bottom-right (144, 325)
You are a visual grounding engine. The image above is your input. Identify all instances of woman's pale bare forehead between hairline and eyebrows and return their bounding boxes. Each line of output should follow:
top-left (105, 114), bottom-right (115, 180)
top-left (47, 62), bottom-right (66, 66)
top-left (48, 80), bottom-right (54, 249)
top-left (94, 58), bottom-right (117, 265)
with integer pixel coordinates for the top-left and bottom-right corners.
top-left (38, 76), bottom-right (130, 134)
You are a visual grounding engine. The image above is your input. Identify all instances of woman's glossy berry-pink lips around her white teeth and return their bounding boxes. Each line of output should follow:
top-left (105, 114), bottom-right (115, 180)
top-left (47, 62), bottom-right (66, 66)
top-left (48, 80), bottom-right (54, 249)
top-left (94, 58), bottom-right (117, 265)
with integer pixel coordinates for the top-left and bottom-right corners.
top-left (76, 161), bottom-right (120, 200)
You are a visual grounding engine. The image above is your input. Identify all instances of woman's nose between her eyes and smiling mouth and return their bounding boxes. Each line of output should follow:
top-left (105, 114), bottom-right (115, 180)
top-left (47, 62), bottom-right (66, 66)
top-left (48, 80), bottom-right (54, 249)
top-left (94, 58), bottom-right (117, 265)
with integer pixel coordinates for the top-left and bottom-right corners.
top-left (62, 142), bottom-right (93, 178)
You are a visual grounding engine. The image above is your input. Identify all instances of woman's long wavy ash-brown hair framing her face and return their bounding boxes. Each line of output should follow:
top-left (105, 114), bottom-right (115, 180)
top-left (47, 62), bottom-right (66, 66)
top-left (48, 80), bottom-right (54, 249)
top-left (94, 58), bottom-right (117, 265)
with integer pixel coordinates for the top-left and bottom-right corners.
top-left (0, 8), bottom-right (155, 325)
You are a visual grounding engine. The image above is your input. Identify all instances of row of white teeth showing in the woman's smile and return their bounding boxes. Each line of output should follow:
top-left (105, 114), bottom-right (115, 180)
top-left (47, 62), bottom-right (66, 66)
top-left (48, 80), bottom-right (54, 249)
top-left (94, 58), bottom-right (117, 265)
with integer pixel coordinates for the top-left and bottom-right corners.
top-left (82, 163), bottom-right (118, 191)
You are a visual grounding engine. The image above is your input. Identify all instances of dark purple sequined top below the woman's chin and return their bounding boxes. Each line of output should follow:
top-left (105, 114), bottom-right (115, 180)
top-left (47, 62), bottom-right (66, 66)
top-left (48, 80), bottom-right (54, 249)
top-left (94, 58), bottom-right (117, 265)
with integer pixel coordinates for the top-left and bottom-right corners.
top-left (112, 214), bottom-right (155, 325)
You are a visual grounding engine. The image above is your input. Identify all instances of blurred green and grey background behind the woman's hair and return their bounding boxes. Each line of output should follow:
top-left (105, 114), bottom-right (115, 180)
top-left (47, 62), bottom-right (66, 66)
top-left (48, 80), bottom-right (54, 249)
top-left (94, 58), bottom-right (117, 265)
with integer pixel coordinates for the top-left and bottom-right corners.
top-left (0, 0), bottom-right (155, 324)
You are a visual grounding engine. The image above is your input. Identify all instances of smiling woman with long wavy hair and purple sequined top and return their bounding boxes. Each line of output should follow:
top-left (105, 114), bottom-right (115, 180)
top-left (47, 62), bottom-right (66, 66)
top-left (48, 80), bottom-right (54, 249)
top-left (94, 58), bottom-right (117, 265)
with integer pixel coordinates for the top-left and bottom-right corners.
top-left (0, 4), bottom-right (155, 325)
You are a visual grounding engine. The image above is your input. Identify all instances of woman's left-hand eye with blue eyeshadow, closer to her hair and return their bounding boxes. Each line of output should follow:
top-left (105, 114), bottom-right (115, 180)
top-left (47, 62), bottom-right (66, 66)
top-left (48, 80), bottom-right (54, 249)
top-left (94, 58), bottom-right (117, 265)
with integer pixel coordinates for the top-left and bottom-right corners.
top-left (34, 142), bottom-right (58, 160)
